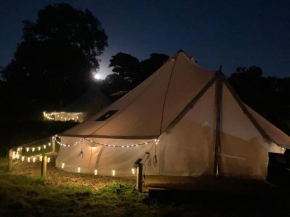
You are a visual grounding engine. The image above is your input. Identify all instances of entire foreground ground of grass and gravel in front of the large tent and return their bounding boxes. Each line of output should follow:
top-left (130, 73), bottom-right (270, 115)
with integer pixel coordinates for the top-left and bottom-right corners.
top-left (0, 160), bottom-right (290, 217)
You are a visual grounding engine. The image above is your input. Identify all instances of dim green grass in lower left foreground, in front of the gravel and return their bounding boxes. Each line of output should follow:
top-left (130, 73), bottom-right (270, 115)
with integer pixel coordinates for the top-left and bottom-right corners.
top-left (0, 174), bottom-right (152, 216)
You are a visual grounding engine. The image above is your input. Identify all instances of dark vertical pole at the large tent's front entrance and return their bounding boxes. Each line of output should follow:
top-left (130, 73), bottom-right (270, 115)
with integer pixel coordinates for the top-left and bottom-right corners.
top-left (214, 69), bottom-right (224, 177)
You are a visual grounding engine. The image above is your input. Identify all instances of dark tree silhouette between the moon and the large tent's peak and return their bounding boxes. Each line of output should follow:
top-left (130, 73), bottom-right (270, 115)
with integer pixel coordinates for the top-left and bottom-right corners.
top-left (102, 52), bottom-right (169, 95)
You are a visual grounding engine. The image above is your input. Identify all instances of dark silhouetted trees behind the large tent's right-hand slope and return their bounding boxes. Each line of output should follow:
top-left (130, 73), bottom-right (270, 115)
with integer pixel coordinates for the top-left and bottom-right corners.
top-left (229, 66), bottom-right (290, 135)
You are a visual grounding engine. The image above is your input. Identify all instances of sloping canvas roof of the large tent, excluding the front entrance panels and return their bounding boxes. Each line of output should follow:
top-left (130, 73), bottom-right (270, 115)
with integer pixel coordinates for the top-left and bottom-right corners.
top-left (61, 50), bottom-right (290, 148)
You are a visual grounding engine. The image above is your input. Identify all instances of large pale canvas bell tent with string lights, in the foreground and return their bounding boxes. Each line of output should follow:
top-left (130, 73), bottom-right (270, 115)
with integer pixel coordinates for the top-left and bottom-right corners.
top-left (56, 51), bottom-right (290, 179)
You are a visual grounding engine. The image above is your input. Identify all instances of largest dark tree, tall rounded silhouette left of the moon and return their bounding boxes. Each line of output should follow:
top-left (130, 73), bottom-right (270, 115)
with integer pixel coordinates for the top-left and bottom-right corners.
top-left (2, 3), bottom-right (108, 109)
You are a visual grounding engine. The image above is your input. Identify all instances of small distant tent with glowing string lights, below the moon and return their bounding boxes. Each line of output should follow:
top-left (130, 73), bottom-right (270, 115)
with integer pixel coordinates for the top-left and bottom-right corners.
top-left (43, 85), bottom-right (111, 123)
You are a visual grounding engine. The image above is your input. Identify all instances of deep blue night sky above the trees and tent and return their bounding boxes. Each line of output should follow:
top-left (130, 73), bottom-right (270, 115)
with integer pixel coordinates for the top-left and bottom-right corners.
top-left (0, 0), bottom-right (290, 77)
